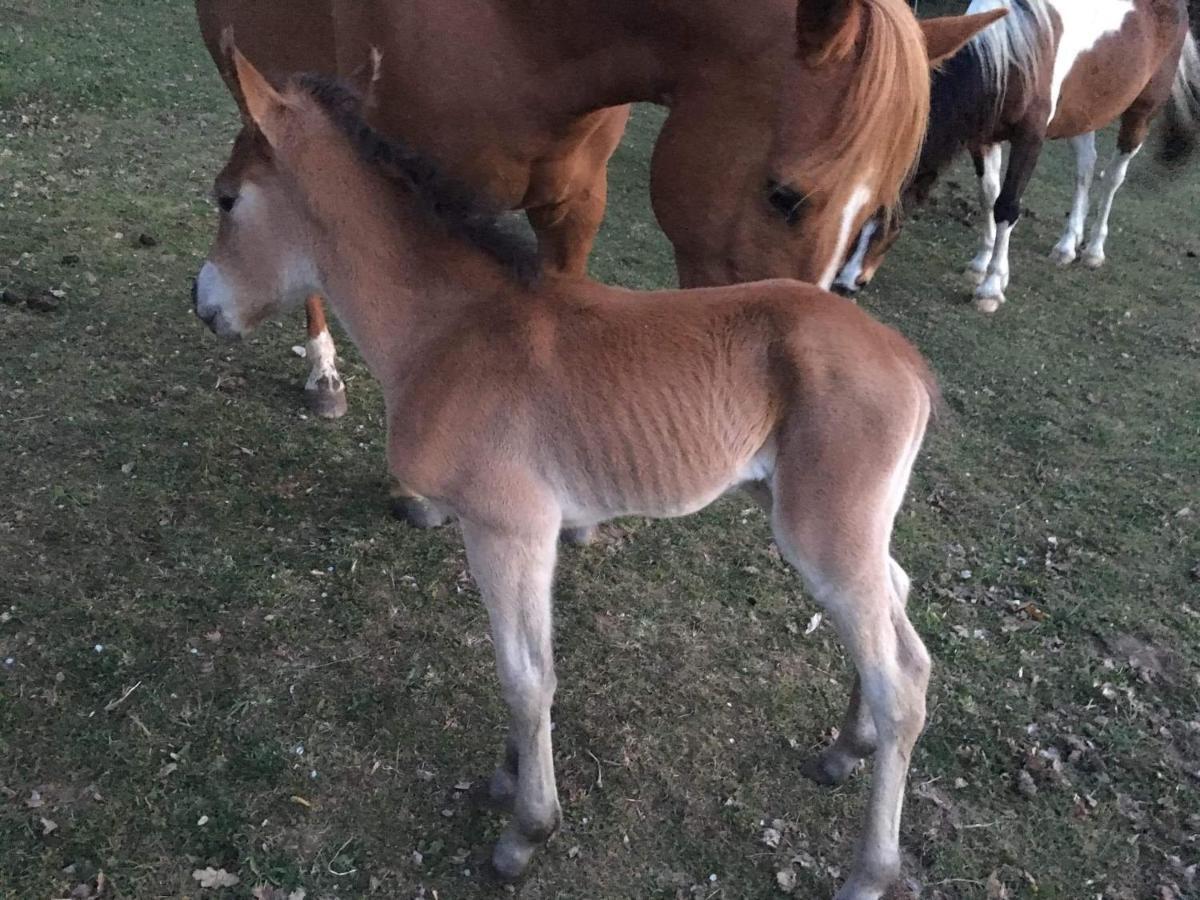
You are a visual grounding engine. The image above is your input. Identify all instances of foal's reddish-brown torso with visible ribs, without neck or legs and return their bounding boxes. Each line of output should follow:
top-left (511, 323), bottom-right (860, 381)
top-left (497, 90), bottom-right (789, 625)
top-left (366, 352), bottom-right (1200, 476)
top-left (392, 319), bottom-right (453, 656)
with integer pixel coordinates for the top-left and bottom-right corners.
top-left (392, 277), bottom-right (932, 520)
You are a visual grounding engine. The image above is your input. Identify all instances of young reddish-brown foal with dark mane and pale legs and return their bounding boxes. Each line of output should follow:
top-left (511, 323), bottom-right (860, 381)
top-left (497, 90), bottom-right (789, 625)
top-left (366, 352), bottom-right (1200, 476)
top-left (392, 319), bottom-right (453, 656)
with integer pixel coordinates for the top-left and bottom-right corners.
top-left (196, 52), bottom-right (936, 900)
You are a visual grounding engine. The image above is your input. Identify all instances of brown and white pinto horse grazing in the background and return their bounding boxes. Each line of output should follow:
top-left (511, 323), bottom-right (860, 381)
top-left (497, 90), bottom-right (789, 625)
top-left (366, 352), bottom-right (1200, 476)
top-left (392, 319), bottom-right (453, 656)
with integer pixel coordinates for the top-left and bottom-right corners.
top-left (838, 0), bottom-right (1200, 312)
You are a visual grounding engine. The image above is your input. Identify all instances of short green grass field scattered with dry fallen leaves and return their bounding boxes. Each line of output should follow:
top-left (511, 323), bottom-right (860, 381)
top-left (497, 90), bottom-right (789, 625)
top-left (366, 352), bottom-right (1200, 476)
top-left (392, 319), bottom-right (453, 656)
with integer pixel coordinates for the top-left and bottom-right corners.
top-left (0, 0), bottom-right (1200, 900)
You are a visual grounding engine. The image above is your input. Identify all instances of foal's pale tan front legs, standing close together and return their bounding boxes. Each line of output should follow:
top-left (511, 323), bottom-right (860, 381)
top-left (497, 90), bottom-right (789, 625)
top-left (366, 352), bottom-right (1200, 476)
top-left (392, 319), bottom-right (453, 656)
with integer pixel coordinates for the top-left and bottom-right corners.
top-left (463, 513), bottom-right (562, 880)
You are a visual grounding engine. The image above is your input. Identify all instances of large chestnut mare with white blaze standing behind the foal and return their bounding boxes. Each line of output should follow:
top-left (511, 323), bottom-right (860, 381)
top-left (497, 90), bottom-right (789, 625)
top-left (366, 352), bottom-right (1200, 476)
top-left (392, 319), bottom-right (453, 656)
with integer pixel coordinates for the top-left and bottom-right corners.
top-left (196, 0), bottom-right (996, 414)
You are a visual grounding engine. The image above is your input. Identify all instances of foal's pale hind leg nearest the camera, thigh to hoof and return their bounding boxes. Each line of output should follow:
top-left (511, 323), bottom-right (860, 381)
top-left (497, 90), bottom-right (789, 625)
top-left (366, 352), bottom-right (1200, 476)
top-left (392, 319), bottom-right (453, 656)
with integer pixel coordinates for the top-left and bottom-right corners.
top-left (774, 445), bottom-right (930, 900)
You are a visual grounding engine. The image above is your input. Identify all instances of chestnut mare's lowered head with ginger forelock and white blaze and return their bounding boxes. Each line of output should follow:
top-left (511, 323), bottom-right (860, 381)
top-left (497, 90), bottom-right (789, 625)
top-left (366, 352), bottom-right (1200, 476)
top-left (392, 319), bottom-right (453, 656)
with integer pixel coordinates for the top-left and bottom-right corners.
top-left (652, 0), bottom-right (1003, 287)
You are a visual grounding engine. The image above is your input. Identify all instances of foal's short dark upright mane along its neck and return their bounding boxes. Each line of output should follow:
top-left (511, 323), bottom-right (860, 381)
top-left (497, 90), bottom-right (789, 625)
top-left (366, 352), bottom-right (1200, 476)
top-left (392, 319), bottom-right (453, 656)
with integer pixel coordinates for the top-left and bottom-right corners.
top-left (296, 74), bottom-right (541, 287)
